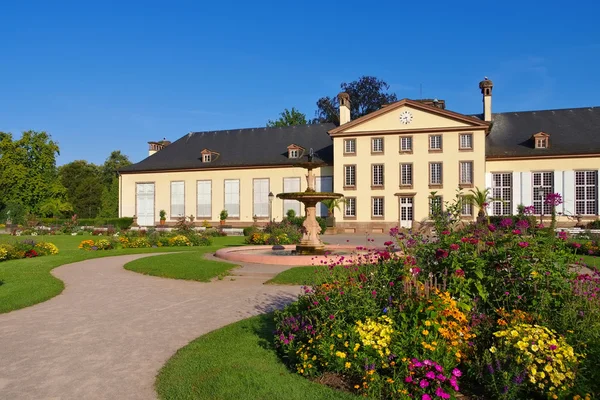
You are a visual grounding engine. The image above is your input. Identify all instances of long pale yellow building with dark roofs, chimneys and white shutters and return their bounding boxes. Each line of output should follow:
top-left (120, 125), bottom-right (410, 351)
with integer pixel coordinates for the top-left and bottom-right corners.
top-left (120, 79), bottom-right (600, 232)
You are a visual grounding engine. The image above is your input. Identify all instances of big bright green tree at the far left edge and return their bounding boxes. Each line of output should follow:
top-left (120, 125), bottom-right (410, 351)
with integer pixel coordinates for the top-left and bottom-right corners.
top-left (0, 131), bottom-right (67, 214)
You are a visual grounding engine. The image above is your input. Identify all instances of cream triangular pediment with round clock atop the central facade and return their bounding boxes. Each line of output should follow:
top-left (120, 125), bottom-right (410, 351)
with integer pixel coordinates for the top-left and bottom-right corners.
top-left (329, 99), bottom-right (489, 136)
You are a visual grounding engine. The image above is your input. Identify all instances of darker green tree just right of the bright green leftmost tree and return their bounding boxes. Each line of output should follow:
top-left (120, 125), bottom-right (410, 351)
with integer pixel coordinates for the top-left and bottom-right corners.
top-left (58, 160), bottom-right (104, 218)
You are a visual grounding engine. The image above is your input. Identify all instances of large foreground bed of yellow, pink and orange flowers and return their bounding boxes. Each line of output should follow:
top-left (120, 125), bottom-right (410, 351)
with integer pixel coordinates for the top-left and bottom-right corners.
top-left (275, 223), bottom-right (600, 399)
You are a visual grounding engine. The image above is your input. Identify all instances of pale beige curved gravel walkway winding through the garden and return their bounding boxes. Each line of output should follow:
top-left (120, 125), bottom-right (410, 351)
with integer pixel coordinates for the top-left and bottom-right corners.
top-left (0, 254), bottom-right (300, 400)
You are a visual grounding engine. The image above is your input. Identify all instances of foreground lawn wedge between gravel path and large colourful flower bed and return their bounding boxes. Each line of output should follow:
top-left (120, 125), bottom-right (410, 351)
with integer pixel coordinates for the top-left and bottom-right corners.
top-left (156, 314), bottom-right (357, 400)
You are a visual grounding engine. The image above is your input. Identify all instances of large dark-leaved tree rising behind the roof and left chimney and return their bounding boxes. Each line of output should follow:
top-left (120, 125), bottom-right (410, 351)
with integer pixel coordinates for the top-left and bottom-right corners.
top-left (313, 76), bottom-right (398, 125)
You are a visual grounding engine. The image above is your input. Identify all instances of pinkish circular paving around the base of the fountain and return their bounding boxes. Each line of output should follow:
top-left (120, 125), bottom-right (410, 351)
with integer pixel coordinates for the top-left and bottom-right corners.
top-left (215, 244), bottom-right (378, 266)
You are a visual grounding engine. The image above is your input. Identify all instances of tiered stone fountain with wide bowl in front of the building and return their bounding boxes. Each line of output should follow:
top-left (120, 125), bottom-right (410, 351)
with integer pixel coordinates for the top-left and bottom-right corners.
top-left (277, 149), bottom-right (343, 255)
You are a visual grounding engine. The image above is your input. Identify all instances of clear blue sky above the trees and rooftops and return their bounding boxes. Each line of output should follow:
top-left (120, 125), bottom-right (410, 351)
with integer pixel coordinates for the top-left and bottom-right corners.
top-left (0, 0), bottom-right (600, 164)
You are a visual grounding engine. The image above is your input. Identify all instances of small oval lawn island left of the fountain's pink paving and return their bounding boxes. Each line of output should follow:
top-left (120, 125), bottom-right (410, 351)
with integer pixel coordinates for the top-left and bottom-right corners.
top-left (125, 249), bottom-right (236, 282)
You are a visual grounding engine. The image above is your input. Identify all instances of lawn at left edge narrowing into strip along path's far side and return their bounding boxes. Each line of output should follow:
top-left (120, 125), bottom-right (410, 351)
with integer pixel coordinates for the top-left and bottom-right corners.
top-left (0, 235), bottom-right (244, 313)
